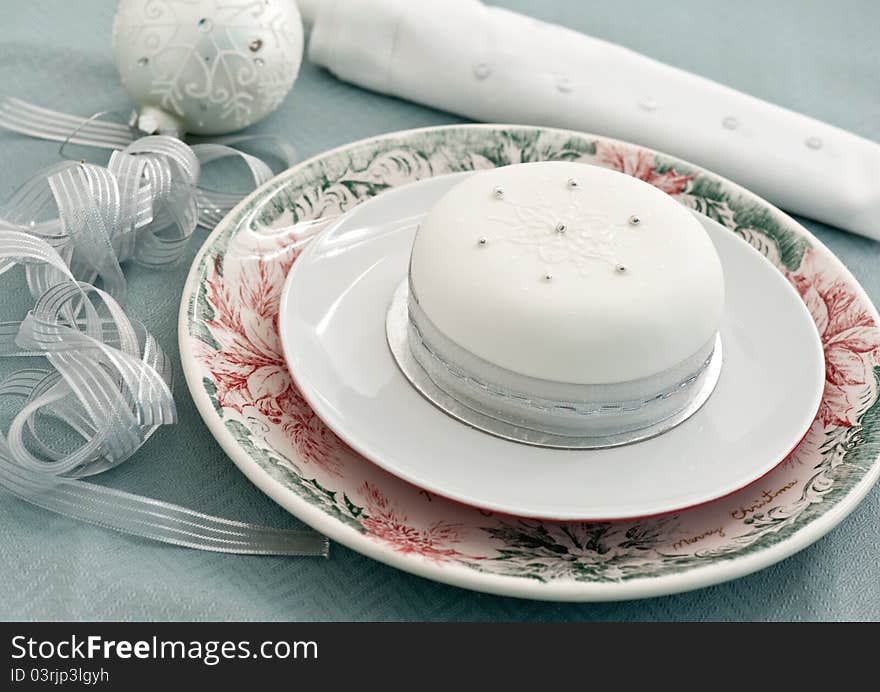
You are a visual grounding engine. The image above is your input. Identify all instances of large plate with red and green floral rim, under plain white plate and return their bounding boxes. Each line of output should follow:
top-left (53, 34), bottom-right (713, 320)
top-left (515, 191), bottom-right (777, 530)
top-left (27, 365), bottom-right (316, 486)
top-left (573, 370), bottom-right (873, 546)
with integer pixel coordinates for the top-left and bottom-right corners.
top-left (180, 125), bottom-right (880, 601)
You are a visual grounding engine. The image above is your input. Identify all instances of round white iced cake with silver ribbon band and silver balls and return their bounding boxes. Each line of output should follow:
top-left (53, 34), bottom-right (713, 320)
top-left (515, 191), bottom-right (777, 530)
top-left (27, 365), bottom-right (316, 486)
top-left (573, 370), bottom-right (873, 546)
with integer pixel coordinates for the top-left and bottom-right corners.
top-left (392, 162), bottom-right (724, 447)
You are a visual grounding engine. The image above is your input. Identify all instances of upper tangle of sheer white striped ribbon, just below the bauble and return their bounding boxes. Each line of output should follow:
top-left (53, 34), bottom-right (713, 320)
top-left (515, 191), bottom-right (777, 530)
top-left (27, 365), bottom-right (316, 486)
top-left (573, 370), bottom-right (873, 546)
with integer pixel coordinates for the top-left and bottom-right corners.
top-left (0, 98), bottom-right (297, 286)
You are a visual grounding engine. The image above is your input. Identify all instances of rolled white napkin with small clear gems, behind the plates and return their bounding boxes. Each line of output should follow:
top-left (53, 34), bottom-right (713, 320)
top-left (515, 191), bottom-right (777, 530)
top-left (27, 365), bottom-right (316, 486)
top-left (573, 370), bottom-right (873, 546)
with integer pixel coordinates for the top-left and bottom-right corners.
top-left (308, 0), bottom-right (880, 239)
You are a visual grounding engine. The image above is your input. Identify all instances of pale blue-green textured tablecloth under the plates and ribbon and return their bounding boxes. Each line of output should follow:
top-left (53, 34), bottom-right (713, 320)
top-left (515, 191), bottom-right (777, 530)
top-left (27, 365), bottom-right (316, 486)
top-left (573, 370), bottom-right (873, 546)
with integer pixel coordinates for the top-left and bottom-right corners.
top-left (0, 0), bottom-right (880, 620)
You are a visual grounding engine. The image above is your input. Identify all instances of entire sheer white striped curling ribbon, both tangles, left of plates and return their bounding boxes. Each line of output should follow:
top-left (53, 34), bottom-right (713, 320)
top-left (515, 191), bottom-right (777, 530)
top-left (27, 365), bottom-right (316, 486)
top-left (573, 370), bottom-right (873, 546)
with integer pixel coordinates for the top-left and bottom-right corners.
top-left (0, 101), bottom-right (328, 555)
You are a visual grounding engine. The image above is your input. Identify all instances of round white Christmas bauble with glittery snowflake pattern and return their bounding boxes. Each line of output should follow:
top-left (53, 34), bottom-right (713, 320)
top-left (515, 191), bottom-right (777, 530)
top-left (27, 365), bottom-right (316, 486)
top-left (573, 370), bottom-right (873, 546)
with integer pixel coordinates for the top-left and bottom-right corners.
top-left (113, 0), bottom-right (303, 135)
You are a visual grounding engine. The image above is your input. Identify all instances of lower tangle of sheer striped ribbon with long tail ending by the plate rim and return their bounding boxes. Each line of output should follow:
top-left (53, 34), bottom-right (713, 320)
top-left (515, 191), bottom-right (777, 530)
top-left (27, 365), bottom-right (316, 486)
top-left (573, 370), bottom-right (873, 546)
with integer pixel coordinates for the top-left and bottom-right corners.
top-left (0, 230), bottom-right (327, 555)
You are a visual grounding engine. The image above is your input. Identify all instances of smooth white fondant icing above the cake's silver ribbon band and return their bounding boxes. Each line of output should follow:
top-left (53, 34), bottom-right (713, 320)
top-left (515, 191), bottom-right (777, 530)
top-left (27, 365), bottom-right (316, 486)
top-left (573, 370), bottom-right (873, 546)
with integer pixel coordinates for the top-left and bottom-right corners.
top-left (410, 162), bottom-right (724, 384)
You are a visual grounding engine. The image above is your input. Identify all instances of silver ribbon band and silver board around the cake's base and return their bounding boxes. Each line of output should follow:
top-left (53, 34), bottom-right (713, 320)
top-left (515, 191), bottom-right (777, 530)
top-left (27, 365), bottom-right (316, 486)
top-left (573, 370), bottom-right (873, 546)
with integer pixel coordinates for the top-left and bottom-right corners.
top-left (386, 281), bottom-right (721, 449)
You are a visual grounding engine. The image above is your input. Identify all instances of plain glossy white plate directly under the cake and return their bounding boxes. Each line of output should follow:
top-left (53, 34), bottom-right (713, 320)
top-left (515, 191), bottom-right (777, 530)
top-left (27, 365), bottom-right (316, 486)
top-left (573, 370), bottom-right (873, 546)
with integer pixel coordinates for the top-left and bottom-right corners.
top-left (279, 174), bottom-right (825, 521)
